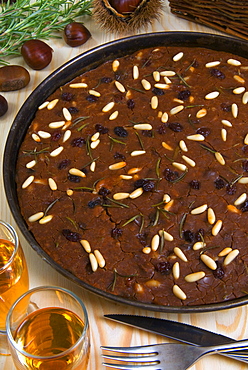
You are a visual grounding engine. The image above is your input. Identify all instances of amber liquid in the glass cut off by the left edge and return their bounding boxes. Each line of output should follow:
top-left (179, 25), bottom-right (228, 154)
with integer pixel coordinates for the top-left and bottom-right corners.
top-left (0, 239), bottom-right (29, 330)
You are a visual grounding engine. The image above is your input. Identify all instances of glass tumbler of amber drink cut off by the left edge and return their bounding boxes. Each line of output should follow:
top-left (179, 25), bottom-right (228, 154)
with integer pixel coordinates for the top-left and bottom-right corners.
top-left (0, 220), bottom-right (29, 355)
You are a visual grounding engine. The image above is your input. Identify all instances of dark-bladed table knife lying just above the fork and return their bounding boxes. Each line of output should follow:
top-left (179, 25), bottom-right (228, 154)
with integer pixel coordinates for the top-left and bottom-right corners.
top-left (104, 314), bottom-right (247, 359)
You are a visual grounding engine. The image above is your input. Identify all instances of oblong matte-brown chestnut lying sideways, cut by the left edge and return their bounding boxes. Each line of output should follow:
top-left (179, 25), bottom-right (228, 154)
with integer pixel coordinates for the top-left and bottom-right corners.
top-left (0, 65), bottom-right (30, 91)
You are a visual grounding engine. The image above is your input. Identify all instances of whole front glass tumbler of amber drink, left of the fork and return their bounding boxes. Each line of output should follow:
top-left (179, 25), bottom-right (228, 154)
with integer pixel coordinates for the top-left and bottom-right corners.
top-left (6, 286), bottom-right (90, 370)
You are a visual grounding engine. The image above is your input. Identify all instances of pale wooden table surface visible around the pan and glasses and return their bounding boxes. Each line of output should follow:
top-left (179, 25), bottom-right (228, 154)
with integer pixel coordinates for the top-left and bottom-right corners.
top-left (0, 1), bottom-right (248, 370)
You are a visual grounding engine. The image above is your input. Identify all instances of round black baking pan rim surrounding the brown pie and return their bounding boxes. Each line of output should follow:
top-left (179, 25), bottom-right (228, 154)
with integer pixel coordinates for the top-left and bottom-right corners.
top-left (3, 32), bottom-right (248, 313)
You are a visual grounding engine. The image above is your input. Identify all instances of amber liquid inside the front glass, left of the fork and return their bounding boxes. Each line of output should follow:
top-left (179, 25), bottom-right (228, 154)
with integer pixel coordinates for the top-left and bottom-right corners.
top-left (14, 307), bottom-right (89, 370)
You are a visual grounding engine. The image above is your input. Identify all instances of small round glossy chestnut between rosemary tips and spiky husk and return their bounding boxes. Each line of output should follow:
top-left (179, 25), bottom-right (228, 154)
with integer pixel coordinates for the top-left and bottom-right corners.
top-left (64, 22), bottom-right (91, 47)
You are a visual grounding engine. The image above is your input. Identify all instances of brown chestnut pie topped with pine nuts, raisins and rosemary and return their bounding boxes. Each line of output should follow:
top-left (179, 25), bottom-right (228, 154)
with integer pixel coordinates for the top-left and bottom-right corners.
top-left (16, 47), bottom-right (248, 306)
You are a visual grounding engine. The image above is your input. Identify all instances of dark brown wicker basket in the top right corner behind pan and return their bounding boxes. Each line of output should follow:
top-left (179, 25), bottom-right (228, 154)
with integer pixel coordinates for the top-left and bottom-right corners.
top-left (169, 0), bottom-right (248, 40)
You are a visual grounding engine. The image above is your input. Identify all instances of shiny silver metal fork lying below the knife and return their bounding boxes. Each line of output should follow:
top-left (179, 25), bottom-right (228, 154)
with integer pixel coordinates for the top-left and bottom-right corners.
top-left (101, 339), bottom-right (248, 370)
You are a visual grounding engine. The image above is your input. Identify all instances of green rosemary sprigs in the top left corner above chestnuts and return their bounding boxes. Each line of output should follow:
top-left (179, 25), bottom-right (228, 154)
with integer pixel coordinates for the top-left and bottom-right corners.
top-left (0, 0), bottom-right (92, 64)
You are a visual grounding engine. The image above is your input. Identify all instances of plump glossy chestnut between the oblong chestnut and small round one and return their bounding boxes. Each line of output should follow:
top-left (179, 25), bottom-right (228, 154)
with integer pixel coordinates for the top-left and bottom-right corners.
top-left (21, 39), bottom-right (53, 70)
